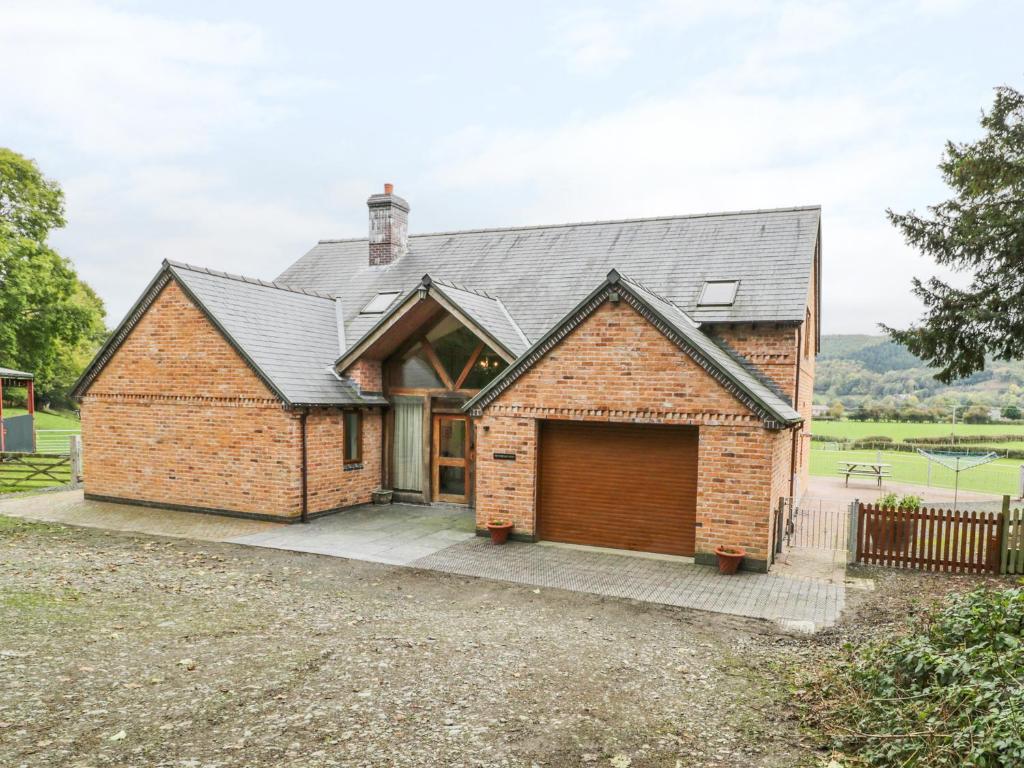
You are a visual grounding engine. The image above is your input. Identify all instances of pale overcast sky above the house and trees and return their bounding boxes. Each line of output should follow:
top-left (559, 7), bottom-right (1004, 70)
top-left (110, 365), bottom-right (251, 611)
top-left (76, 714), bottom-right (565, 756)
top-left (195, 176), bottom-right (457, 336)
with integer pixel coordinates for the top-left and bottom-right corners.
top-left (0, 0), bottom-right (1024, 333)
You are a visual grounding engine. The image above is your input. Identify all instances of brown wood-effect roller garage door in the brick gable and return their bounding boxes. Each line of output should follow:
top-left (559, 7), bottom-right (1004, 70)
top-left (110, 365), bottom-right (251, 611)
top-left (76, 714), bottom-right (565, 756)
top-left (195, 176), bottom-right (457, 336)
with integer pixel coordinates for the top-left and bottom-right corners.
top-left (538, 421), bottom-right (697, 555)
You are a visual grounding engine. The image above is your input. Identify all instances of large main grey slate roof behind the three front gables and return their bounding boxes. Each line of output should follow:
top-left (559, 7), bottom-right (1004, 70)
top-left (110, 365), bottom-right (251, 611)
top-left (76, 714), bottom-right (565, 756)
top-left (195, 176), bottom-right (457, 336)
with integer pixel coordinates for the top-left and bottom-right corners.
top-left (278, 206), bottom-right (821, 350)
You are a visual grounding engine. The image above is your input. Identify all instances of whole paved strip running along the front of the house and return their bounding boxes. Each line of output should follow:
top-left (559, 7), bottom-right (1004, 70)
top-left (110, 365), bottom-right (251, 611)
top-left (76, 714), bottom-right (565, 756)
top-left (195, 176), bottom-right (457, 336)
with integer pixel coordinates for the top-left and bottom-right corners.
top-left (0, 490), bottom-right (845, 632)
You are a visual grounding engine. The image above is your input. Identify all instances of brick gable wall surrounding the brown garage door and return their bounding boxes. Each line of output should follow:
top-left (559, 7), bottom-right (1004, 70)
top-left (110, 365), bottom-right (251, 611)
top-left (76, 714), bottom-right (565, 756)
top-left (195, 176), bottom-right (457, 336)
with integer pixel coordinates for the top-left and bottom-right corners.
top-left (476, 303), bottom-right (777, 560)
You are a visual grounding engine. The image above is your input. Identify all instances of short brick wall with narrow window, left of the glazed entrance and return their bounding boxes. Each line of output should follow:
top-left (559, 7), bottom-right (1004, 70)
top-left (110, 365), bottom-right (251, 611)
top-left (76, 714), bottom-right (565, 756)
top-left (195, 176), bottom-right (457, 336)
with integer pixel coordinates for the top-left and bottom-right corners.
top-left (306, 408), bottom-right (382, 513)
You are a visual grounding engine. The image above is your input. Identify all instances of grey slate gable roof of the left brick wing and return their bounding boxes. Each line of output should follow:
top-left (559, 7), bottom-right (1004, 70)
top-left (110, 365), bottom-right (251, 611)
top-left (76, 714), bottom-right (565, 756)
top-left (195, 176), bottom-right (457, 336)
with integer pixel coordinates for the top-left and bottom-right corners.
top-left (73, 261), bottom-right (385, 407)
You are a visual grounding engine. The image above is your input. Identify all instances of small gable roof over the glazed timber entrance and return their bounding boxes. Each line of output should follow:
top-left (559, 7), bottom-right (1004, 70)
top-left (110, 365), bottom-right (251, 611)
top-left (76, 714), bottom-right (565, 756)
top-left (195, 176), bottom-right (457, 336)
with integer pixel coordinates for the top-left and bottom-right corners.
top-left (335, 274), bottom-right (529, 373)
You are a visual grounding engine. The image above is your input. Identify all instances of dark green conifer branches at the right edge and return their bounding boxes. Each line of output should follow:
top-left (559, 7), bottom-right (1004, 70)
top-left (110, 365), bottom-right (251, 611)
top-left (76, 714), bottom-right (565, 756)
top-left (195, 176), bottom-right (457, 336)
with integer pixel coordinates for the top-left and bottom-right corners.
top-left (885, 86), bottom-right (1024, 383)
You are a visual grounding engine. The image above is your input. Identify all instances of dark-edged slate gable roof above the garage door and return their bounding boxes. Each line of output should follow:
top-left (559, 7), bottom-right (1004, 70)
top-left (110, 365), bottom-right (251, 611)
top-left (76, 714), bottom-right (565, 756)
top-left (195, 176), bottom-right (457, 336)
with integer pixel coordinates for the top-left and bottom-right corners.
top-left (463, 269), bottom-right (803, 429)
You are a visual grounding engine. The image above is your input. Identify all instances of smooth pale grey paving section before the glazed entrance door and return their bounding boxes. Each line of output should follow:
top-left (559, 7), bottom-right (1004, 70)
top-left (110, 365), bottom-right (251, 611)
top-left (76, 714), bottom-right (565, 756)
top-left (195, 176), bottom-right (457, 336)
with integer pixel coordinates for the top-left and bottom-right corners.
top-left (225, 504), bottom-right (476, 565)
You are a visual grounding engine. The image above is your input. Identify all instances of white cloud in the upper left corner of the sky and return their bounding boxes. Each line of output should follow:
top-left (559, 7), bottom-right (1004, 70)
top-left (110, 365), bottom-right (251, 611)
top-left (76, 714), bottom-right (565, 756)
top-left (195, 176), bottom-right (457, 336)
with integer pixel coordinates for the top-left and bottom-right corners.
top-left (0, 0), bottom-right (272, 159)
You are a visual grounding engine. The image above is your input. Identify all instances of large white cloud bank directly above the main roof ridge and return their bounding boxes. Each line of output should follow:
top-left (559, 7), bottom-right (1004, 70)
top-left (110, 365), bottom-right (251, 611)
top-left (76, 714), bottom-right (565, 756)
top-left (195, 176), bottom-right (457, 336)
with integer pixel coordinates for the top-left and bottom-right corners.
top-left (435, 79), bottom-right (958, 333)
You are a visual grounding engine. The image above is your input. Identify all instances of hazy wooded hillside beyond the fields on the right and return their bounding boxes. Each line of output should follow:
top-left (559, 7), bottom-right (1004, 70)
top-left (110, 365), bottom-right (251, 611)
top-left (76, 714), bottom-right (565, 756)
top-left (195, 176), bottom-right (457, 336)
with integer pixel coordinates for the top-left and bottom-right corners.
top-left (814, 334), bottom-right (1024, 408)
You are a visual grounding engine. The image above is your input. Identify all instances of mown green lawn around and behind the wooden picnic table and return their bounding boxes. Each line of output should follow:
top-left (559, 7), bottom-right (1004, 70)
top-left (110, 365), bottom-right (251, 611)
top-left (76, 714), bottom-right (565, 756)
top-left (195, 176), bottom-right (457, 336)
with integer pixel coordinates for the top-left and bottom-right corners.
top-left (811, 443), bottom-right (1024, 497)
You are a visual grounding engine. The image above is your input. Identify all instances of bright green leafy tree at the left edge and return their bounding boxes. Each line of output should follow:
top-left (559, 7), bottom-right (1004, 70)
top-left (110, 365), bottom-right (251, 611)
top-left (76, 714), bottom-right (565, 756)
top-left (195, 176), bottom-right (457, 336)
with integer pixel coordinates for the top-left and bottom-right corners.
top-left (0, 147), bottom-right (105, 399)
